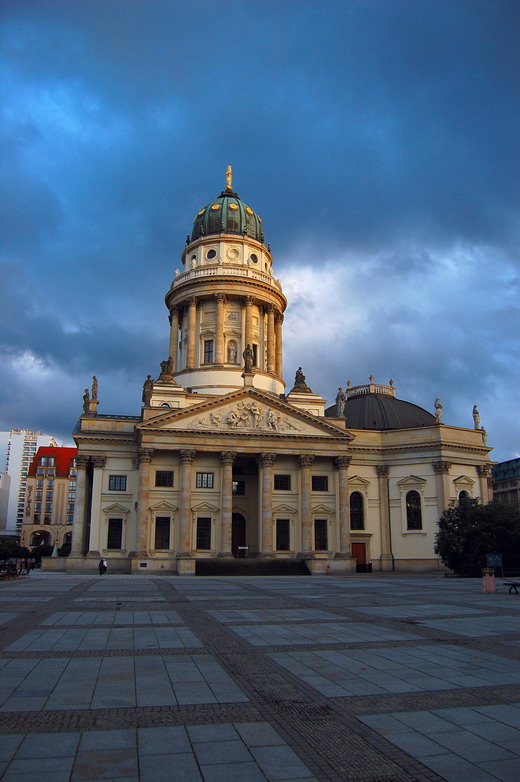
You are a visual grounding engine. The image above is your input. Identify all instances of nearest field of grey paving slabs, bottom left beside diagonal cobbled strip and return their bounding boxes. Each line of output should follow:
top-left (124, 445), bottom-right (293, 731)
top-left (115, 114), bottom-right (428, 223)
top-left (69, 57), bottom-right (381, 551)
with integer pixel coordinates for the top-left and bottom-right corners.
top-left (0, 722), bottom-right (316, 782)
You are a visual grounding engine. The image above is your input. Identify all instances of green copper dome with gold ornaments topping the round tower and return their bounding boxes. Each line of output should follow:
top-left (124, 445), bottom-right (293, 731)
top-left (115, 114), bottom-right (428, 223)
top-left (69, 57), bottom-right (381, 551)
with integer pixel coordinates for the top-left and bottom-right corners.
top-left (191, 188), bottom-right (264, 243)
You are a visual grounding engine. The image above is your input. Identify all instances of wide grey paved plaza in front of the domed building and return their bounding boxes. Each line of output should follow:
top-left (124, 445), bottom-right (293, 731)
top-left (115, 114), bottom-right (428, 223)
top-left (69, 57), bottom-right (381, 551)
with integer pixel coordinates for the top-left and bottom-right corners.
top-left (0, 571), bottom-right (520, 782)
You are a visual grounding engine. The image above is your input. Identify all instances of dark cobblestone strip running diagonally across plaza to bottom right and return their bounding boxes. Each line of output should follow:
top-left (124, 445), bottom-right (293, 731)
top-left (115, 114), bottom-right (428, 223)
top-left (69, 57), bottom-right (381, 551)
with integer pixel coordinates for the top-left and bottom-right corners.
top-left (155, 581), bottom-right (441, 782)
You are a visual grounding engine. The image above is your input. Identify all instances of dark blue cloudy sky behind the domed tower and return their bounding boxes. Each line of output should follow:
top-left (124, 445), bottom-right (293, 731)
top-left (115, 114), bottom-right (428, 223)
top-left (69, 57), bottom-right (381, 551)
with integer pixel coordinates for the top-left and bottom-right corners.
top-left (0, 0), bottom-right (520, 461)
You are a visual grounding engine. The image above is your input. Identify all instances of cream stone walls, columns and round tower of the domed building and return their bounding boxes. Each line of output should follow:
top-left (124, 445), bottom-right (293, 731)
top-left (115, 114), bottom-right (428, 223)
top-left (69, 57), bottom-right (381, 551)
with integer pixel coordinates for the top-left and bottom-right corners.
top-left (67, 176), bottom-right (490, 575)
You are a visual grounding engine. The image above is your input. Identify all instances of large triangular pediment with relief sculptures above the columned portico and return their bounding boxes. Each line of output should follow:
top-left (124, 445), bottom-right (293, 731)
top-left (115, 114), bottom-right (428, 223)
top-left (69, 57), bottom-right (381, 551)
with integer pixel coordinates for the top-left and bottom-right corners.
top-left (136, 387), bottom-right (354, 442)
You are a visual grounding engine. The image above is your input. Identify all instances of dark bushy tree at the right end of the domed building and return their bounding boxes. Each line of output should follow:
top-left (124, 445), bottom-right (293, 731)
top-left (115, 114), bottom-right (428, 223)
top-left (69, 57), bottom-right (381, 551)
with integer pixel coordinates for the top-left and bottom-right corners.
top-left (435, 498), bottom-right (520, 574)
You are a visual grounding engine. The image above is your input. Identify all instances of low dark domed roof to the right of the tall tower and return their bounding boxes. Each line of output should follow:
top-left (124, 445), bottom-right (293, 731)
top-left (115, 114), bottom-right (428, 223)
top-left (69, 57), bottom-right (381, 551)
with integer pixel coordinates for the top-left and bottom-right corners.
top-left (325, 394), bottom-right (435, 429)
